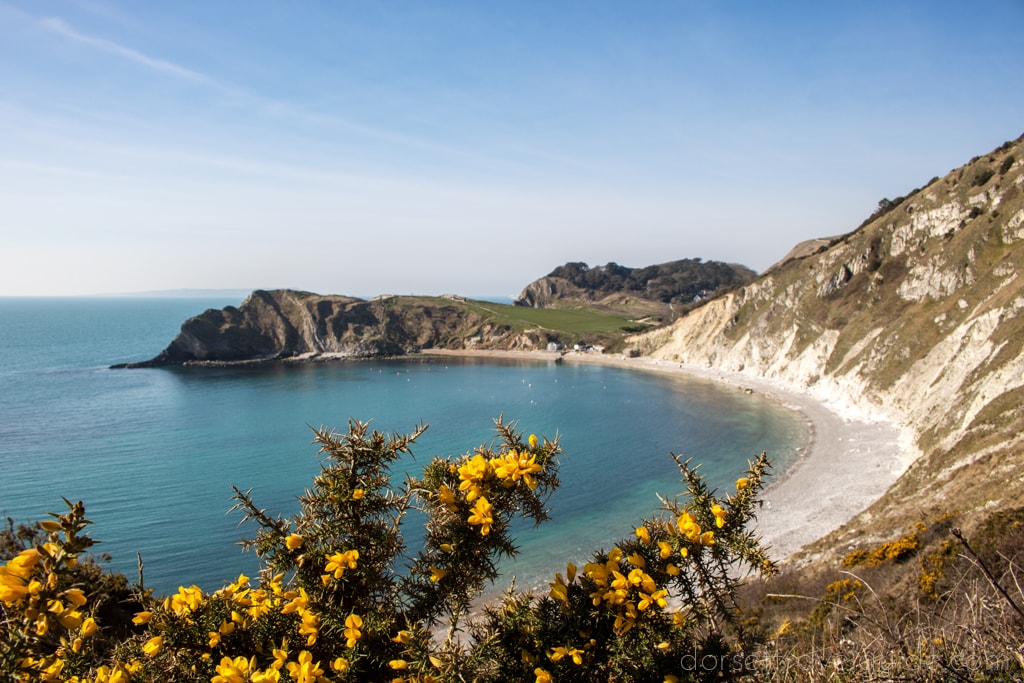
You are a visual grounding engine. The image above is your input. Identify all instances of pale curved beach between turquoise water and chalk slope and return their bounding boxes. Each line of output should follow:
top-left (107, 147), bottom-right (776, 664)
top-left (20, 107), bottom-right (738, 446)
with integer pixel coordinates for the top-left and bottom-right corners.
top-left (415, 350), bottom-right (913, 559)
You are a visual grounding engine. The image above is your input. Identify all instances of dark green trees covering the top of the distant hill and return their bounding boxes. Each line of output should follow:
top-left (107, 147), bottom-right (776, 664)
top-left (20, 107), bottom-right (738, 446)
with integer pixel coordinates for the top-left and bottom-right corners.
top-left (548, 258), bottom-right (757, 303)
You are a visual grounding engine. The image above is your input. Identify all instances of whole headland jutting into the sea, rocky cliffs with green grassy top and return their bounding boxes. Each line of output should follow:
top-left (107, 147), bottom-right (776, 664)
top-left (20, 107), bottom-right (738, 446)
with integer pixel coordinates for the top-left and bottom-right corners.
top-left (116, 290), bottom-right (643, 368)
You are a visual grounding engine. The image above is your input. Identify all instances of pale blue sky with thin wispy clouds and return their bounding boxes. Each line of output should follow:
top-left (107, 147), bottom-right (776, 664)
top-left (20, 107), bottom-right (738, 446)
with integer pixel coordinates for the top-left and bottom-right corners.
top-left (0, 0), bottom-right (1024, 296)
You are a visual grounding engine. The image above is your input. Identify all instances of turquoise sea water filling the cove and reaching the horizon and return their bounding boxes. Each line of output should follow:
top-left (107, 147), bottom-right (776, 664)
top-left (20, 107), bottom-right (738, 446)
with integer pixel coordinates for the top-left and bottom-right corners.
top-left (0, 299), bottom-right (808, 592)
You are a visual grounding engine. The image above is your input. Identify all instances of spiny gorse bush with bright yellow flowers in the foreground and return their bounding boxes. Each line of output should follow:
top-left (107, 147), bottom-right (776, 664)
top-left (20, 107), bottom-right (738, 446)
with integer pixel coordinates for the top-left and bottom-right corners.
top-left (0, 419), bottom-right (775, 683)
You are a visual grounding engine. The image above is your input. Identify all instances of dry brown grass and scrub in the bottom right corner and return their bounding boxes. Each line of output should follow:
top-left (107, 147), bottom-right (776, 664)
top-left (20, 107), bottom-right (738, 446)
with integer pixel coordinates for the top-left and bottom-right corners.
top-left (740, 510), bottom-right (1024, 682)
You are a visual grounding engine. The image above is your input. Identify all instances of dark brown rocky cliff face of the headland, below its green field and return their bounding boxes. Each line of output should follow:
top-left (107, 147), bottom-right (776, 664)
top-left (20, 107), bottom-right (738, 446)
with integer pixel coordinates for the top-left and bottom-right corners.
top-left (132, 290), bottom-right (544, 367)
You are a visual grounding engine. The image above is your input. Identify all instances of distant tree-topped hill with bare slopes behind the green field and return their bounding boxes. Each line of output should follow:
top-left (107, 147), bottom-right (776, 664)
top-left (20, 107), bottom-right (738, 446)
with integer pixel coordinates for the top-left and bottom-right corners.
top-left (515, 258), bottom-right (757, 322)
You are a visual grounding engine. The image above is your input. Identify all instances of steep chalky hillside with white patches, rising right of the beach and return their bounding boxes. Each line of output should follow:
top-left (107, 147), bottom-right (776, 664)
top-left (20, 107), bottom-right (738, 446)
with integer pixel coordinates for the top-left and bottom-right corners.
top-left (629, 132), bottom-right (1024, 554)
